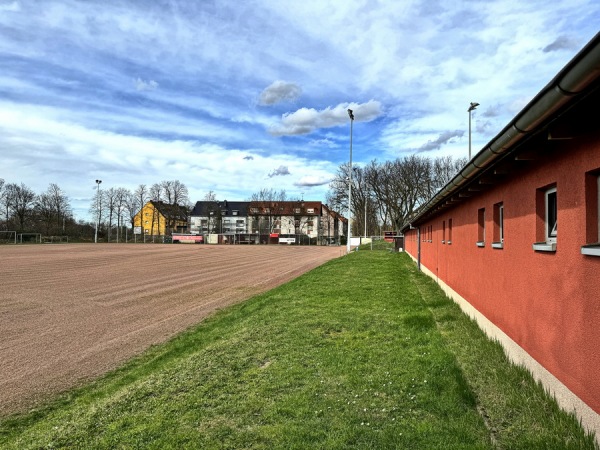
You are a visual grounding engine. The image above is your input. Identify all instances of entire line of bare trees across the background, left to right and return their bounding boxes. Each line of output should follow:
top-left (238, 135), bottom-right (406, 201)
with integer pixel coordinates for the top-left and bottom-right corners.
top-left (0, 155), bottom-right (467, 241)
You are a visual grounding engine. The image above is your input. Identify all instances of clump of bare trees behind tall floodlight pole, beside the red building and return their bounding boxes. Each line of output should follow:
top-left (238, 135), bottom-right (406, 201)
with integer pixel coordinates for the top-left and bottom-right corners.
top-left (327, 155), bottom-right (467, 236)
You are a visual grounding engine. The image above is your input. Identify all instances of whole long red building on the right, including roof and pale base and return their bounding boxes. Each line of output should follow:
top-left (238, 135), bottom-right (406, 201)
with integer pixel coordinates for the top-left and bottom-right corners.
top-left (403, 34), bottom-right (600, 438)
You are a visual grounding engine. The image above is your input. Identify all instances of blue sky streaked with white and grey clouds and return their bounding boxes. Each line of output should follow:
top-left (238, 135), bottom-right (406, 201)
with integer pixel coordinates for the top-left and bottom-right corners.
top-left (0, 0), bottom-right (600, 219)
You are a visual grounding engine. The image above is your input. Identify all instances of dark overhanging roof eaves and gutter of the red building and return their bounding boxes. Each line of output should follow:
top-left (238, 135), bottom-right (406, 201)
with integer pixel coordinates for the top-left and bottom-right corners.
top-left (402, 33), bottom-right (600, 230)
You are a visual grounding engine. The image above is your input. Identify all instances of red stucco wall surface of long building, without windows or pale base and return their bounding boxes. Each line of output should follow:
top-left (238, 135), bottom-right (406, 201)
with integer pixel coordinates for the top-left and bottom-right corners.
top-left (405, 135), bottom-right (600, 414)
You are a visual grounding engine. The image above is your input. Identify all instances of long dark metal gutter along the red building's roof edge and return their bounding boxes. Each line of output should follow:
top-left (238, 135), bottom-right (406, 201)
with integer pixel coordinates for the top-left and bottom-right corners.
top-left (402, 33), bottom-right (600, 230)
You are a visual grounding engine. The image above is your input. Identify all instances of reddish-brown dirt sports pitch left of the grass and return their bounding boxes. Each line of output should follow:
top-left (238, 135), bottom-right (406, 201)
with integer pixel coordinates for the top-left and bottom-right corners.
top-left (0, 244), bottom-right (344, 416)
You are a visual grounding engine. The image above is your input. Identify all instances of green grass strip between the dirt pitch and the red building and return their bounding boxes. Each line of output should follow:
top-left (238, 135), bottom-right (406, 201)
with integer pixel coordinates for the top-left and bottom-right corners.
top-left (0, 251), bottom-right (595, 449)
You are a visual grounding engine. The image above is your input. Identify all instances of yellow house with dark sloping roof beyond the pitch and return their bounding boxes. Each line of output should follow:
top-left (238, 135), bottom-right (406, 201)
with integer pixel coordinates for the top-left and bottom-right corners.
top-left (133, 200), bottom-right (188, 236)
